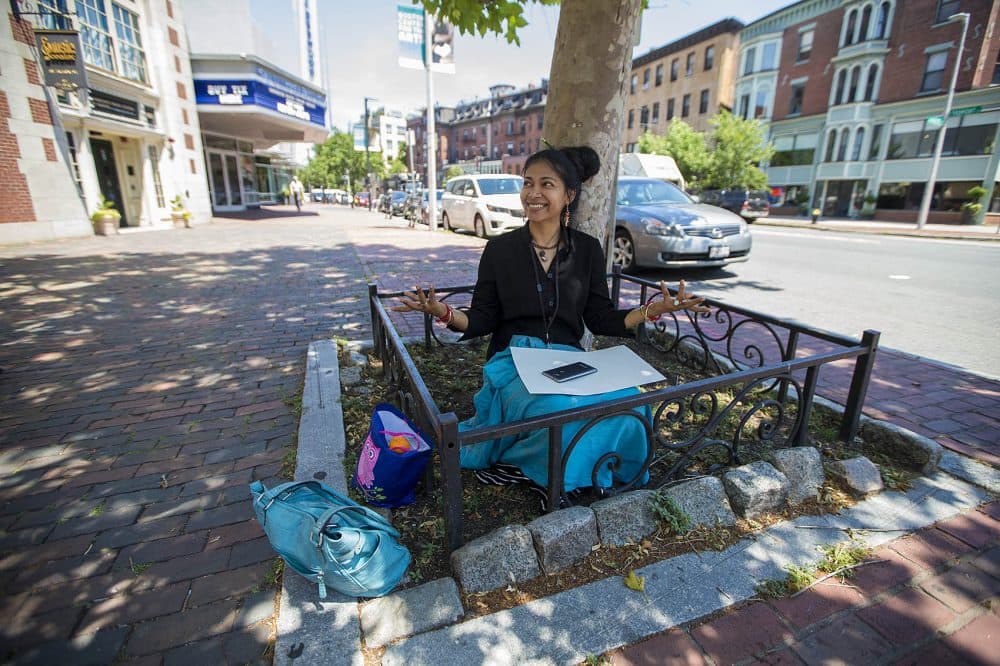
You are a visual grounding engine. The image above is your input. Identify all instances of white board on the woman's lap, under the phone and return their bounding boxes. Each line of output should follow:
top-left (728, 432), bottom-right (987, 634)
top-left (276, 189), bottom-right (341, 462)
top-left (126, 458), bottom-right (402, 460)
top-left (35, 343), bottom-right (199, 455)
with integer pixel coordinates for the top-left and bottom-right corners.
top-left (510, 345), bottom-right (666, 395)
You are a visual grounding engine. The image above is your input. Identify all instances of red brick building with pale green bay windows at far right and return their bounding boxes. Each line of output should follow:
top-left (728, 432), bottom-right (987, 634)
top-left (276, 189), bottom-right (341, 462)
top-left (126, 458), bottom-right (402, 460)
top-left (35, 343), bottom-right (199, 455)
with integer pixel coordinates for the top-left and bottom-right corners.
top-left (756, 0), bottom-right (1000, 222)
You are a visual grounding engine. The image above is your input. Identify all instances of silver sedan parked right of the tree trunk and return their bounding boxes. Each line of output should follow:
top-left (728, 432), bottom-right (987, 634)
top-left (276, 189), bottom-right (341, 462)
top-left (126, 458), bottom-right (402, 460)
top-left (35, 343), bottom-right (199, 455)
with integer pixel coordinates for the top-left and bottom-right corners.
top-left (612, 177), bottom-right (753, 272)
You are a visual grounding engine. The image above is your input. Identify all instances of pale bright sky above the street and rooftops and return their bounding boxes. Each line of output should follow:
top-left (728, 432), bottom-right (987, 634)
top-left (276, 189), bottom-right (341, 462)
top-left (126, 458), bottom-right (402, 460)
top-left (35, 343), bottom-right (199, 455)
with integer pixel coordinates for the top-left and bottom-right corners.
top-left (251, 0), bottom-right (793, 130)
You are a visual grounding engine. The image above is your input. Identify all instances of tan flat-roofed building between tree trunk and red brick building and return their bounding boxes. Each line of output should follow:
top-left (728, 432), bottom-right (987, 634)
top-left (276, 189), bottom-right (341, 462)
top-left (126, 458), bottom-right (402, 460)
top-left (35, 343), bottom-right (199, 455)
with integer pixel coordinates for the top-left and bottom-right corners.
top-left (622, 18), bottom-right (743, 152)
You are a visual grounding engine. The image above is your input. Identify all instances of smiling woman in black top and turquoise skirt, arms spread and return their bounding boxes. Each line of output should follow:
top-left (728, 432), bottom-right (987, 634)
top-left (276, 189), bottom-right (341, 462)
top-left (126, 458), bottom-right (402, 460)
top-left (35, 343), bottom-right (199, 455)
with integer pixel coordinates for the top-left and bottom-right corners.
top-left (392, 146), bottom-right (708, 492)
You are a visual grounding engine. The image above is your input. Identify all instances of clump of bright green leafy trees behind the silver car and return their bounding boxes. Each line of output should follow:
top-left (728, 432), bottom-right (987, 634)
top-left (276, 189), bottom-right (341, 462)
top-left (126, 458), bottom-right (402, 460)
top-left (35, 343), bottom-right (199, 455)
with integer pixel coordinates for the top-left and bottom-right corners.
top-left (639, 111), bottom-right (774, 192)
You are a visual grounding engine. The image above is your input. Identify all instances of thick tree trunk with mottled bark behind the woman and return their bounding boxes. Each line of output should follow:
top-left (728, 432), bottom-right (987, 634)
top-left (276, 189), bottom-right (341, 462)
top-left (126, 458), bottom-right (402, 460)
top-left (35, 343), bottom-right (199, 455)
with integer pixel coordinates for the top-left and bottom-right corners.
top-left (543, 0), bottom-right (642, 254)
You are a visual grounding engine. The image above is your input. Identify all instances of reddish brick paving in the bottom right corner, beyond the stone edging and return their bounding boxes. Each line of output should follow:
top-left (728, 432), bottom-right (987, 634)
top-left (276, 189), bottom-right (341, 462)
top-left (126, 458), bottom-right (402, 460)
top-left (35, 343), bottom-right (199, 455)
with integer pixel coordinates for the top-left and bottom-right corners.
top-left (607, 502), bottom-right (1000, 666)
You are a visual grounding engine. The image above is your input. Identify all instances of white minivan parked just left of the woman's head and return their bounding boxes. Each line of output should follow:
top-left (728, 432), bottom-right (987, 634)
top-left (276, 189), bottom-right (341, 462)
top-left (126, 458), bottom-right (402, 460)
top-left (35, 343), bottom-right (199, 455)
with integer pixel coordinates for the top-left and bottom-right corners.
top-left (441, 174), bottom-right (524, 238)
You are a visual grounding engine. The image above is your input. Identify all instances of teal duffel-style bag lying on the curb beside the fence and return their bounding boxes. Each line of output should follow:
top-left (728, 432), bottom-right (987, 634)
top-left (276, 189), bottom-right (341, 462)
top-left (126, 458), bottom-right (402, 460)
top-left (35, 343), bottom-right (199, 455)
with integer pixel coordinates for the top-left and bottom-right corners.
top-left (250, 481), bottom-right (410, 599)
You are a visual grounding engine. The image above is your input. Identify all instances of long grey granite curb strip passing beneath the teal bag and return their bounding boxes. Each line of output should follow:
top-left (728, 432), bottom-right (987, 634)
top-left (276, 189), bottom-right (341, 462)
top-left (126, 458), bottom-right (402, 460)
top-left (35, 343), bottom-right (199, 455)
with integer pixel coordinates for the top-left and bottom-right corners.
top-left (274, 340), bottom-right (365, 666)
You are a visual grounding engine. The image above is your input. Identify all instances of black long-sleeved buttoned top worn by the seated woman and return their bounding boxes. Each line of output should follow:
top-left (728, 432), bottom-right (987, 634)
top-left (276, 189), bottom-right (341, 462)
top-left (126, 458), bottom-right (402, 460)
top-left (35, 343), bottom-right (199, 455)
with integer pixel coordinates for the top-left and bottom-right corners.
top-left (461, 225), bottom-right (631, 359)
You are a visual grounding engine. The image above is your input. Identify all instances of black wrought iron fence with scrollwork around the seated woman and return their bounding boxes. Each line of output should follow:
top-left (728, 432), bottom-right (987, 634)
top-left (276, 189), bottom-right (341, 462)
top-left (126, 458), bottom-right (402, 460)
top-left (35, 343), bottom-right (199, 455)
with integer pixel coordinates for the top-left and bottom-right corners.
top-left (369, 269), bottom-right (879, 549)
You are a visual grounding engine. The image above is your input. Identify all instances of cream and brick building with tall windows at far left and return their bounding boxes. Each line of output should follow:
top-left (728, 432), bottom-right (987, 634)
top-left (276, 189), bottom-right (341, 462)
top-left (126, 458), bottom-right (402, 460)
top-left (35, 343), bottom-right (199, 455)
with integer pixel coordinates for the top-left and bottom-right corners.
top-left (0, 0), bottom-right (209, 243)
